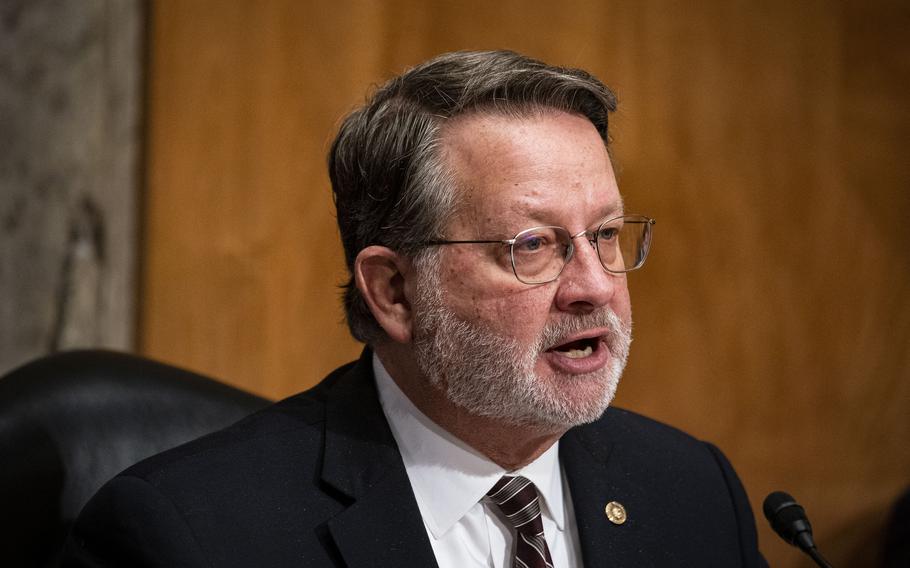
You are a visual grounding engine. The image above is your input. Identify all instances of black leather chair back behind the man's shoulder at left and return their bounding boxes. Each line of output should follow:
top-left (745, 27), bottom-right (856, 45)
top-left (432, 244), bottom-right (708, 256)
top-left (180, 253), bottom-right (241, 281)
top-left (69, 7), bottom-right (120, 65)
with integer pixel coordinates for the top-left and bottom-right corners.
top-left (0, 351), bottom-right (269, 567)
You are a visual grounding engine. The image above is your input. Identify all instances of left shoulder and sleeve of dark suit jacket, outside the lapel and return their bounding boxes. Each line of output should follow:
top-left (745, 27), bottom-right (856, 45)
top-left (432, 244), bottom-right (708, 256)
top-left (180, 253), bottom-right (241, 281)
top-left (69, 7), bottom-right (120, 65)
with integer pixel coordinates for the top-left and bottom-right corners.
top-left (67, 358), bottom-right (370, 566)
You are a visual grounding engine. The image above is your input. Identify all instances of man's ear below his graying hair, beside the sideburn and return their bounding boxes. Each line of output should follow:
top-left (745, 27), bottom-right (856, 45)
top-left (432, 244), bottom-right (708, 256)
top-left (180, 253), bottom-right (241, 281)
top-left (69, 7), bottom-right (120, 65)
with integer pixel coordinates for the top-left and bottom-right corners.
top-left (354, 246), bottom-right (413, 343)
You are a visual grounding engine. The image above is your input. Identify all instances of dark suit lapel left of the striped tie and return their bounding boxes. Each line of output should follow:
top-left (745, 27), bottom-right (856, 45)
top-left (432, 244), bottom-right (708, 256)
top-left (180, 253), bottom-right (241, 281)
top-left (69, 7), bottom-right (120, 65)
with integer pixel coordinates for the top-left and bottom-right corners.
top-left (322, 350), bottom-right (436, 568)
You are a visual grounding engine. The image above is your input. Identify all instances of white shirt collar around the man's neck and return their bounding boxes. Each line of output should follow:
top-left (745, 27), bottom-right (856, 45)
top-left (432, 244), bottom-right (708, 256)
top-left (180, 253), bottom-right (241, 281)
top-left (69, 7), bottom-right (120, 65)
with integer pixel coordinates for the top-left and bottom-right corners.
top-left (373, 354), bottom-right (566, 539)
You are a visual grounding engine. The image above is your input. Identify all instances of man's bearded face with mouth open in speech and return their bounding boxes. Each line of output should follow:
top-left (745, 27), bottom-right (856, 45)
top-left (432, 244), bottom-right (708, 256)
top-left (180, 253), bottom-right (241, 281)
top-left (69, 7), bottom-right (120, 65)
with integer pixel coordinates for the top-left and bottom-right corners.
top-left (413, 112), bottom-right (631, 428)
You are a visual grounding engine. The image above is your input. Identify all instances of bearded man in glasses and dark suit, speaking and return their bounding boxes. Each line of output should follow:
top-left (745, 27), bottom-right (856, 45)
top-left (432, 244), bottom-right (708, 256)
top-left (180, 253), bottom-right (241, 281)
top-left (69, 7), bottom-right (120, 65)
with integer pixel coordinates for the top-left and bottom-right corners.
top-left (68, 52), bottom-right (764, 567)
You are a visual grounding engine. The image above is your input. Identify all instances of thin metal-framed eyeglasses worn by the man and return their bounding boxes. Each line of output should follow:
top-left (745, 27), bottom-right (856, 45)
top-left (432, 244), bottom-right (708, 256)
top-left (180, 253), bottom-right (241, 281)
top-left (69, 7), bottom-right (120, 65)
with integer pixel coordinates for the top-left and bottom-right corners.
top-left (424, 215), bottom-right (656, 284)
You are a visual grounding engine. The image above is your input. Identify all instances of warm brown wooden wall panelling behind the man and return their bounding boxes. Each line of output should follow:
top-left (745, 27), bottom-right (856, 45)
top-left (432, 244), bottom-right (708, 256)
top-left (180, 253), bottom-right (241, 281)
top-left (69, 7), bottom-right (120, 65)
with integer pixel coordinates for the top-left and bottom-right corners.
top-left (146, 0), bottom-right (910, 566)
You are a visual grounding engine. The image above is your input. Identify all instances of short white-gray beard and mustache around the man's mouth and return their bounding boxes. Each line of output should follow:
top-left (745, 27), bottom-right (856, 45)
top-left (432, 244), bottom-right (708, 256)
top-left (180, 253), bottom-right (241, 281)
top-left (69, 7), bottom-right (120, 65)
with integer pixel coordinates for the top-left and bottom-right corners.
top-left (413, 267), bottom-right (632, 429)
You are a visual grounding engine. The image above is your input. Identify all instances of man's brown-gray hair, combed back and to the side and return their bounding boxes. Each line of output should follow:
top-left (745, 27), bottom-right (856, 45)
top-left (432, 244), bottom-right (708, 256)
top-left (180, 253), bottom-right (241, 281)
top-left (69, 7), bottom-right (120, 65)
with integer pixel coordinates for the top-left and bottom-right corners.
top-left (328, 51), bottom-right (616, 344)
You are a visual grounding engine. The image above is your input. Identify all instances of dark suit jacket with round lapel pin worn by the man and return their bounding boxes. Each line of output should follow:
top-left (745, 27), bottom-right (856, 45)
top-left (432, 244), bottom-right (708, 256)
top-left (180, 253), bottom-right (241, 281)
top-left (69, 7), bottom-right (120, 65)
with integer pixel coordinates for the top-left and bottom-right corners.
top-left (64, 351), bottom-right (764, 568)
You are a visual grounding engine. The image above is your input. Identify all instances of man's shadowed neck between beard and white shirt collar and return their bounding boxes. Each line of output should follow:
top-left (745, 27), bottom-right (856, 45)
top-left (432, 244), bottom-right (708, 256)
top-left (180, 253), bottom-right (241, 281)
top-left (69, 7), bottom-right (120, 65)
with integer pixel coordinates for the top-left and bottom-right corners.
top-left (376, 346), bottom-right (565, 471)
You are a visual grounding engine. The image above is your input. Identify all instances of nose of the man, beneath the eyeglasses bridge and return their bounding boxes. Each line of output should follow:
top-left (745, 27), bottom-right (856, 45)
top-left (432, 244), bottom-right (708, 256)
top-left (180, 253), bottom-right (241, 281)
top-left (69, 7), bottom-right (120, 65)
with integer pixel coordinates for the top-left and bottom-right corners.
top-left (556, 233), bottom-right (626, 314)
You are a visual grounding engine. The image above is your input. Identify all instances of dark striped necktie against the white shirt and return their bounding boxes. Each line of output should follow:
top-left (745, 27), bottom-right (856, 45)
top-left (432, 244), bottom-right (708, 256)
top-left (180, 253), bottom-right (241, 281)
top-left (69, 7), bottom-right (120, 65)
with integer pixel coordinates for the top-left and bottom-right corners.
top-left (487, 475), bottom-right (553, 568)
